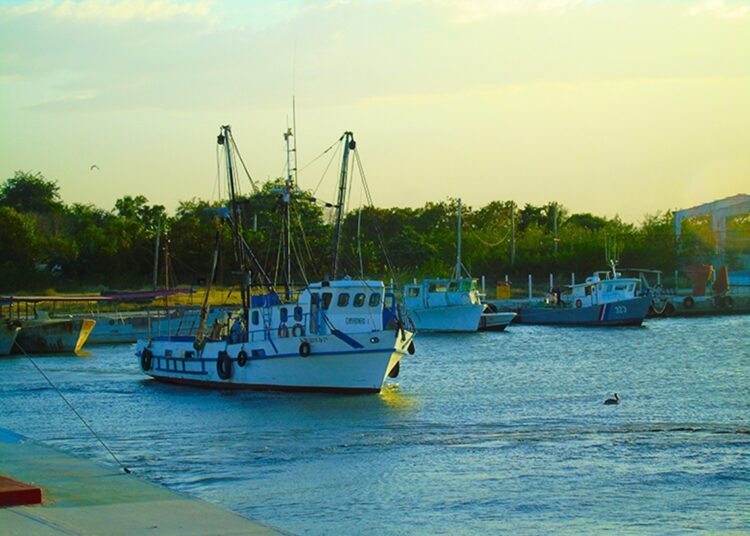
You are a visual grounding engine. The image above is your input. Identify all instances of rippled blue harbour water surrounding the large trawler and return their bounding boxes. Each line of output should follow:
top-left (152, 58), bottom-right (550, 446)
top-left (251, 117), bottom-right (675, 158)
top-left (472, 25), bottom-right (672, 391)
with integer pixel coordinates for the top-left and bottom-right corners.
top-left (0, 316), bottom-right (750, 534)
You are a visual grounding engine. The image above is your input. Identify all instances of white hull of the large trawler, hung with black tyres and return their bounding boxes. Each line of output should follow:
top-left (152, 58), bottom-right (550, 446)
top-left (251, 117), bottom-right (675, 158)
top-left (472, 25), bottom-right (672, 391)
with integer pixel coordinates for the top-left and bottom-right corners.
top-left (137, 330), bottom-right (413, 393)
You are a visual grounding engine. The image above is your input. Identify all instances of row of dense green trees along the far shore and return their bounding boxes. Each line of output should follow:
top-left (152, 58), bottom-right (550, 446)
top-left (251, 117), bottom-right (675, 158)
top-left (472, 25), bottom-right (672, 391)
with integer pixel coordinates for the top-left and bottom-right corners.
top-left (0, 171), bottom-right (750, 293)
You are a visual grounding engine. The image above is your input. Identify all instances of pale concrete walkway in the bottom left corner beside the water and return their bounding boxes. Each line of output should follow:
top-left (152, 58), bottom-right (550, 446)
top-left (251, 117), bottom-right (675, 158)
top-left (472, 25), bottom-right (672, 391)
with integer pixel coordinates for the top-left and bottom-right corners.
top-left (0, 428), bottom-right (280, 536)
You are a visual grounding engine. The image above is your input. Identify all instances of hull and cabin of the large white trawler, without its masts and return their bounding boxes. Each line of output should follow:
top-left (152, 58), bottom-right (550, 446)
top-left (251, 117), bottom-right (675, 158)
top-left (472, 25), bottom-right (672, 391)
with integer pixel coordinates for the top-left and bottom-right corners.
top-left (137, 280), bottom-right (414, 393)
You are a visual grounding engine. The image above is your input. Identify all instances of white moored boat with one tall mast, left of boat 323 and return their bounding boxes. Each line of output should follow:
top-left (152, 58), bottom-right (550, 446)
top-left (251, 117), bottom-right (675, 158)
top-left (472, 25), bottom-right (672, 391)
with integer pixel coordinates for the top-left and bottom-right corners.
top-left (404, 199), bottom-right (488, 332)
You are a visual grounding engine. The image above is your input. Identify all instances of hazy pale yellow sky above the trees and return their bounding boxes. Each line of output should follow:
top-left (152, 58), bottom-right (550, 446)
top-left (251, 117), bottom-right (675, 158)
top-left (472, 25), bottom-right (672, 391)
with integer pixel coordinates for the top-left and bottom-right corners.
top-left (0, 0), bottom-right (750, 222)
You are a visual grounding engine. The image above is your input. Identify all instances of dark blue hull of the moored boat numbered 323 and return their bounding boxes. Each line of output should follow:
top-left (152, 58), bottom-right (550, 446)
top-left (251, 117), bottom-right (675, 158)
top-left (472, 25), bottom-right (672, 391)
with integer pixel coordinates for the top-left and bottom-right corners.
top-left (518, 296), bottom-right (651, 326)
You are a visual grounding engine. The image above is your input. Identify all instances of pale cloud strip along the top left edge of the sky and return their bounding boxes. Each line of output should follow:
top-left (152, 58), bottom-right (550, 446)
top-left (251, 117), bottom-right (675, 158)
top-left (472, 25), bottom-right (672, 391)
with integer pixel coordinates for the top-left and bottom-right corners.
top-left (0, 0), bottom-right (211, 22)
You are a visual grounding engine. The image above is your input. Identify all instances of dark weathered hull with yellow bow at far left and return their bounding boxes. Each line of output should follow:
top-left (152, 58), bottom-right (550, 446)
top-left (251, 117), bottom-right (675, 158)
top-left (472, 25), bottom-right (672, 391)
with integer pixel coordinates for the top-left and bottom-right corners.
top-left (13, 318), bottom-right (96, 354)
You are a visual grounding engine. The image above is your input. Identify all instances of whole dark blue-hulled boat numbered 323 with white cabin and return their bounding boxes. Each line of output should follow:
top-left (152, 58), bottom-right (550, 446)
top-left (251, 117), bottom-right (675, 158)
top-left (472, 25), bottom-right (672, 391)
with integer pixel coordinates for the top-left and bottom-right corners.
top-left (518, 264), bottom-right (651, 326)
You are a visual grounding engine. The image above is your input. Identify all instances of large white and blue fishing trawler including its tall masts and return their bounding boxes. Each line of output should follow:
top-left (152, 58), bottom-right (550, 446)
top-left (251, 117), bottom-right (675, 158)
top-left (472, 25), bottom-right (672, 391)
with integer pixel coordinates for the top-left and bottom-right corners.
top-left (136, 126), bottom-right (415, 393)
